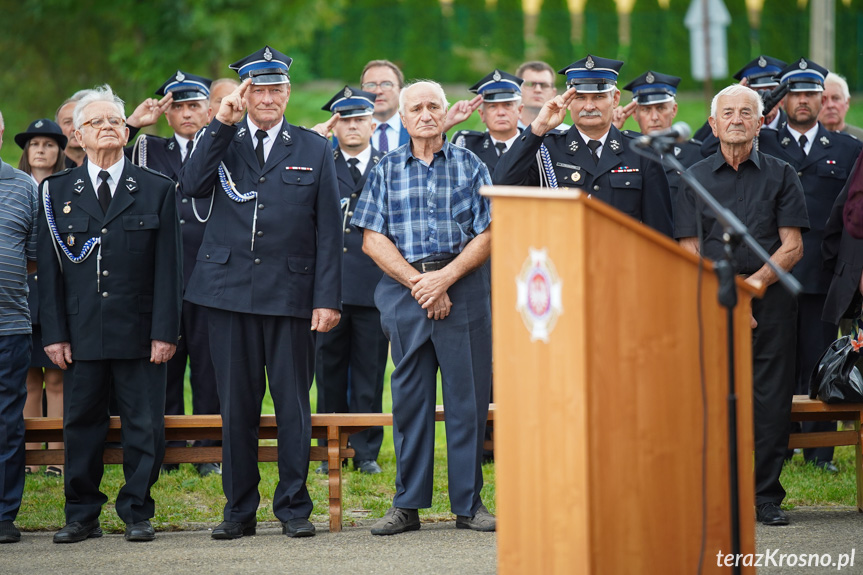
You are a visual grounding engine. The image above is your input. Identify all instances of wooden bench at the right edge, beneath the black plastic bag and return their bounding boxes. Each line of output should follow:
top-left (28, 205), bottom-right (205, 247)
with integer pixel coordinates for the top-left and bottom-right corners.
top-left (788, 395), bottom-right (863, 512)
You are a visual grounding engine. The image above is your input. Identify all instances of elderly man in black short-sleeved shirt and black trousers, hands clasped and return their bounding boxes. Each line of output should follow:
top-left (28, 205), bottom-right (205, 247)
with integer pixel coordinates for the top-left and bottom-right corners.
top-left (674, 84), bottom-right (809, 525)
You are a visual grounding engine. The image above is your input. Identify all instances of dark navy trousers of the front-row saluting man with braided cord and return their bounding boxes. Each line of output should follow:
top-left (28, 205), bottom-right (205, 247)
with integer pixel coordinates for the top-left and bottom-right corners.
top-left (208, 308), bottom-right (315, 522)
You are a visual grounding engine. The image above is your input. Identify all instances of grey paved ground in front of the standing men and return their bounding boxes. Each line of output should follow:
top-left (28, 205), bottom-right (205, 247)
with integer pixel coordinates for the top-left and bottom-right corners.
top-left (6, 507), bottom-right (863, 575)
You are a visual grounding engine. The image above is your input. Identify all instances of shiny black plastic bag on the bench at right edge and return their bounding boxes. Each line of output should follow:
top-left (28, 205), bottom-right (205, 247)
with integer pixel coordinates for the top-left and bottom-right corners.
top-left (809, 331), bottom-right (863, 403)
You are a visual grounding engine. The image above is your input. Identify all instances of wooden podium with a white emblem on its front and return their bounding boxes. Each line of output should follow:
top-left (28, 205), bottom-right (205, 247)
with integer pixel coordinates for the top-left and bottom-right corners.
top-left (483, 186), bottom-right (757, 575)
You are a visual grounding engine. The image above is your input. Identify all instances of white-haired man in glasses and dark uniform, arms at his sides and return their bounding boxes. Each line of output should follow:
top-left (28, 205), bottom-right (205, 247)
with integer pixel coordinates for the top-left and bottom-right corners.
top-left (38, 86), bottom-right (183, 543)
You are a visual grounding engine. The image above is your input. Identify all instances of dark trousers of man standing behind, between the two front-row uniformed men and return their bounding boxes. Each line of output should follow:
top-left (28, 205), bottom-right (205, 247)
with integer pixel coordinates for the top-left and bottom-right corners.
top-left (165, 301), bottom-right (221, 447)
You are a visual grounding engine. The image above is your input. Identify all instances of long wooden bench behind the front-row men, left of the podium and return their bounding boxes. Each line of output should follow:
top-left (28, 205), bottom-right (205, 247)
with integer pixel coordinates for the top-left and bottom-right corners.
top-left (24, 404), bottom-right (495, 532)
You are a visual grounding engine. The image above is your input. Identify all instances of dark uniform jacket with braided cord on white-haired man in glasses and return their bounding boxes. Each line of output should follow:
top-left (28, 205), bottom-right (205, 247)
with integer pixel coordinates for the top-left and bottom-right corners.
top-left (38, 159), bottom-right (182, 360)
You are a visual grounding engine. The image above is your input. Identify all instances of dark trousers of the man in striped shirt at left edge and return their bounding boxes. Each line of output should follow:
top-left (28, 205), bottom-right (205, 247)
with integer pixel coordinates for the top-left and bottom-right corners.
top-left (0, 333), bottom-right (33, 521)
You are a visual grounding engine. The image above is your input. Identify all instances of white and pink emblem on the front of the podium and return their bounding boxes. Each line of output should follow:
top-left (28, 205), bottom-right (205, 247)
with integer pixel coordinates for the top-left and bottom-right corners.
top-left (515, 248), bottom-right (563, 343)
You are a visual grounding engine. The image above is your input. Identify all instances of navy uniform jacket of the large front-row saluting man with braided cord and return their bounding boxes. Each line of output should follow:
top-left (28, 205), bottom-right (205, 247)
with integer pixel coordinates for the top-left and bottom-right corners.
top-left (180, 119), bottom-right (343, 318)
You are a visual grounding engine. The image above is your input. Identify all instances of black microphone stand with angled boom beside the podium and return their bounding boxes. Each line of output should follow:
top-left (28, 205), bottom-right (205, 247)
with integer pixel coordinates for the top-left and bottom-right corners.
top-left (632, 136), bottom-right (802, 573)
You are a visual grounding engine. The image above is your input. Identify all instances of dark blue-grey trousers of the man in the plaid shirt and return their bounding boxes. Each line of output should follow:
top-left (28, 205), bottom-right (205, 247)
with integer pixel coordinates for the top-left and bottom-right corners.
top-left (375, 266), bottom-right (491, 516)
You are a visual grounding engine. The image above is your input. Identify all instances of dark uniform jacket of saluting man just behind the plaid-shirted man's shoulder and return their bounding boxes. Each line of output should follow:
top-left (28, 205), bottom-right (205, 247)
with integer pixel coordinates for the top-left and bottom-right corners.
top-left (333, 148), bottom-right (383, 307)
